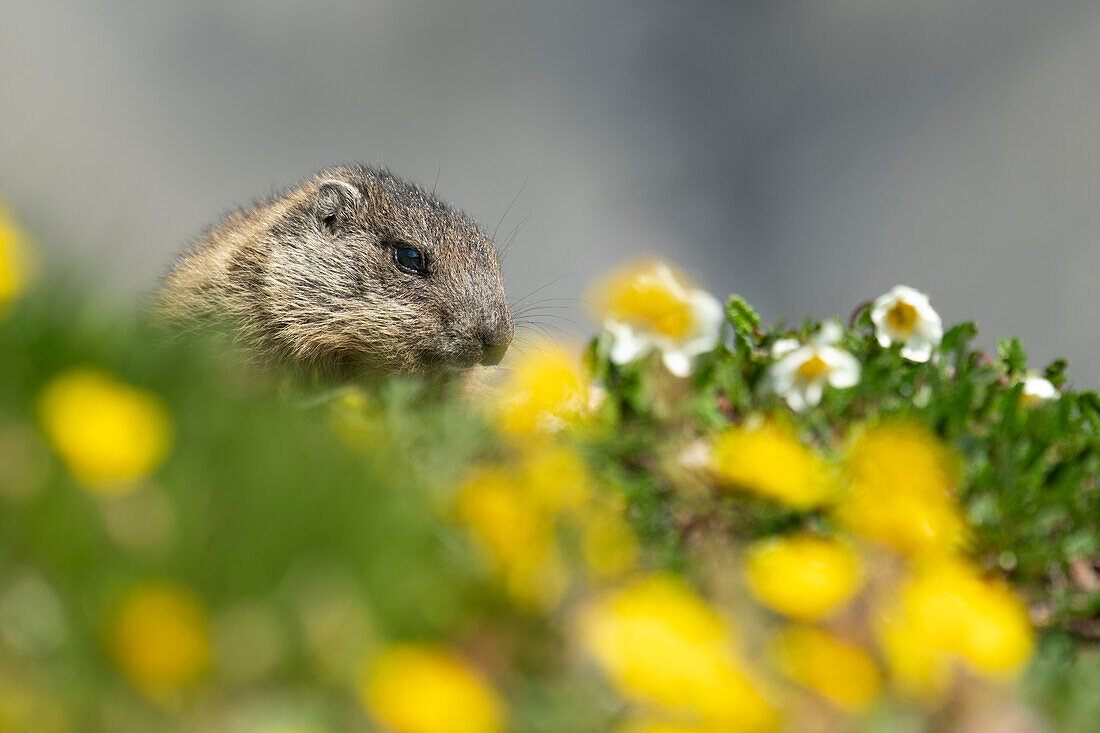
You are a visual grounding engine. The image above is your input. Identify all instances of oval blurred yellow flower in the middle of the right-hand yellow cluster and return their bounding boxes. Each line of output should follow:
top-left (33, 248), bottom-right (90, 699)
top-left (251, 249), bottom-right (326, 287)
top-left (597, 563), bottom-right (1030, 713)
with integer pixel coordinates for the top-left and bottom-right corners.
top-left (745, 535), bottom-right (862, 621)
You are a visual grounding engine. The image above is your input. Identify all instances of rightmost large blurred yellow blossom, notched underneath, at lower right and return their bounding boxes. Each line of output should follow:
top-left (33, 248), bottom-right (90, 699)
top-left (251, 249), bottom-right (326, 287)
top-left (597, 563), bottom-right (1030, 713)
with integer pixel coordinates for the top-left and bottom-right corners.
top-left (878, 559), bottom-right (1035, 696)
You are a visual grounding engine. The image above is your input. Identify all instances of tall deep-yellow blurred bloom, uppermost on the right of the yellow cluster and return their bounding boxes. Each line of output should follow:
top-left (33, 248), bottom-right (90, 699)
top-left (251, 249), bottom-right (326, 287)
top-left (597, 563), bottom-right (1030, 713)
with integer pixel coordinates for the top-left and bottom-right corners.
top-left (836, 423), bottom-right (966, 556)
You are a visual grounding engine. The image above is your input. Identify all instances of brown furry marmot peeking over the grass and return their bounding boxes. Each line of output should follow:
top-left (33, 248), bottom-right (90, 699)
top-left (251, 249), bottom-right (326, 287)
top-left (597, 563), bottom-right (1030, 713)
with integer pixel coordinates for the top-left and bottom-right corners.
top-left (157, 165), bottom-right (514, 374)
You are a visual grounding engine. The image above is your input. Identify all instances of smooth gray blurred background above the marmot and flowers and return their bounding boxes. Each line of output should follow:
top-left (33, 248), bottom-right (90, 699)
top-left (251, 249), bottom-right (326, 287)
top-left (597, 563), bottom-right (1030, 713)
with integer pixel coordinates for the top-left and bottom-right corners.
top-left (0, 0), bottom-right (1100, 387)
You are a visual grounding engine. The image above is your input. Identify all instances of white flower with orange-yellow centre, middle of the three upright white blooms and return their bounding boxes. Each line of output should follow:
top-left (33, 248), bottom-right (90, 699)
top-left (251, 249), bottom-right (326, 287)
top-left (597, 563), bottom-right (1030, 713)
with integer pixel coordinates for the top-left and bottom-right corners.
top-left (768, 321), bottom-right (860, 413)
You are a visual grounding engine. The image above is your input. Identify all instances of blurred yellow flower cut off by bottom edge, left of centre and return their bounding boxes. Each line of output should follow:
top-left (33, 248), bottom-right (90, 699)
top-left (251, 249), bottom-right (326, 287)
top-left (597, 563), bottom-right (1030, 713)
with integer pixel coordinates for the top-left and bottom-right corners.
top-left (361, 644), bottom-right (504, 733)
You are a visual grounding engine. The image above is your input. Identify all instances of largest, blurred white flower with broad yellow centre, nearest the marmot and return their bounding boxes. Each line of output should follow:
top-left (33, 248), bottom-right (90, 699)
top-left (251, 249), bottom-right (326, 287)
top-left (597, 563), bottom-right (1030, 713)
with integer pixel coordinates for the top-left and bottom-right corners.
top-left (604, 262), bottom-right (725, 376)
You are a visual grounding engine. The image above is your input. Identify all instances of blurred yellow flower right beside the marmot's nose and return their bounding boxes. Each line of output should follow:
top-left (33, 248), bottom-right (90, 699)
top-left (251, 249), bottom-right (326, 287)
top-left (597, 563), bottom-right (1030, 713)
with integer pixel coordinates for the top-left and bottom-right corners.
top-left (496, 344), bottom-right (589, 436)
